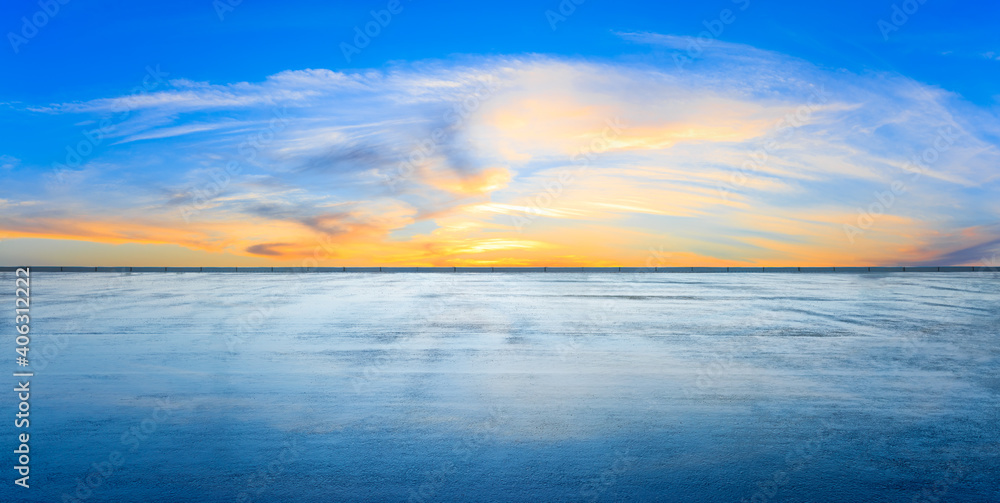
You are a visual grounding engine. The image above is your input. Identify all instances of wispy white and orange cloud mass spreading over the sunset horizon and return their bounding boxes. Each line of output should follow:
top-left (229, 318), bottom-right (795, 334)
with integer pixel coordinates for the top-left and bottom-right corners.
top-left (0, 38), bottom-right (1000, 265)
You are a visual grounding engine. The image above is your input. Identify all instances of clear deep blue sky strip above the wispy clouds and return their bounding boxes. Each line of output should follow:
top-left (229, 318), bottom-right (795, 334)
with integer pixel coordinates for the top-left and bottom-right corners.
top-left (0, 0), bottom-right (1000, 104)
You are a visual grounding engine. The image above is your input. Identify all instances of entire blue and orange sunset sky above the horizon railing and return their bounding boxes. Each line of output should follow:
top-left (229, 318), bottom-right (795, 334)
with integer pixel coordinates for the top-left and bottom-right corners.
top-left (0, 0), bottom-right (1000, 266)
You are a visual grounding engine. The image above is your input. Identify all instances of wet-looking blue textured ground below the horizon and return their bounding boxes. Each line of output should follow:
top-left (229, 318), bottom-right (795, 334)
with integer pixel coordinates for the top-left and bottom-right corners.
top-left (0, 273), bottom-right (1000, 502)
